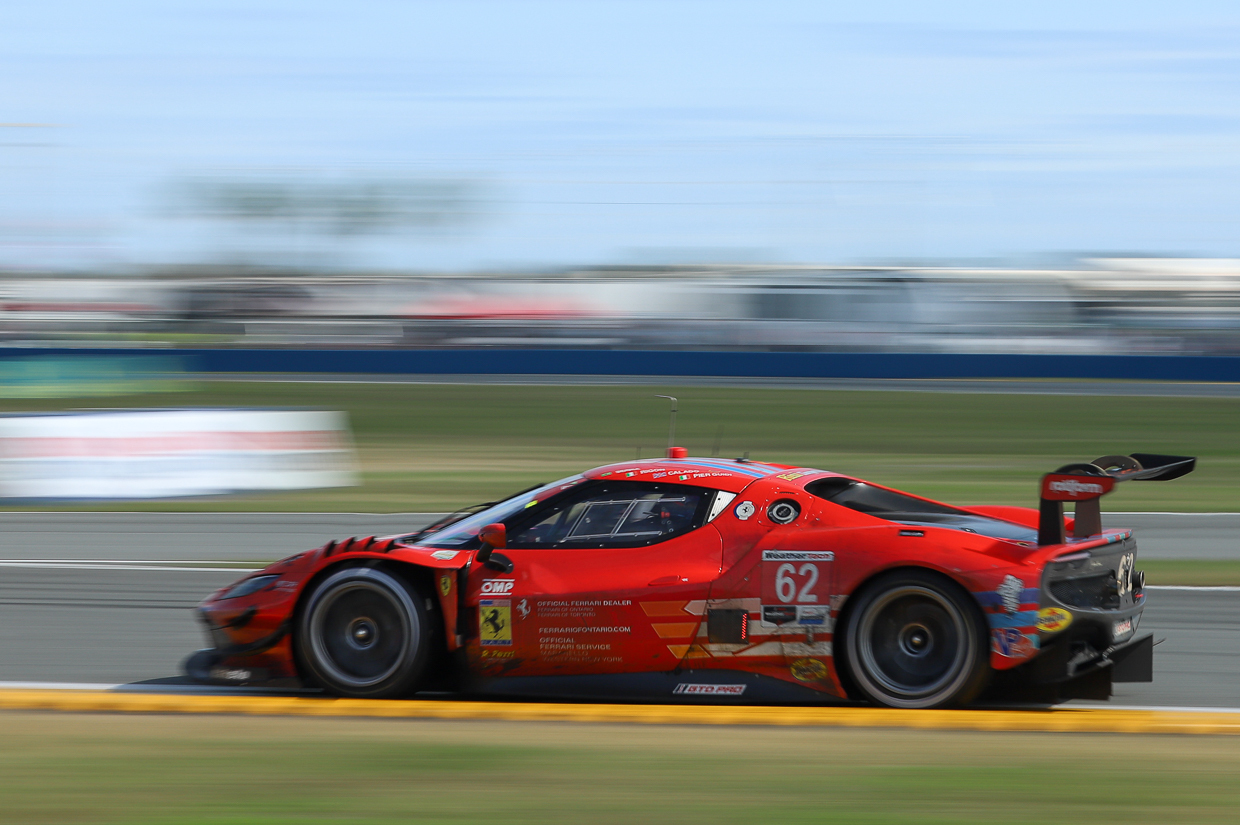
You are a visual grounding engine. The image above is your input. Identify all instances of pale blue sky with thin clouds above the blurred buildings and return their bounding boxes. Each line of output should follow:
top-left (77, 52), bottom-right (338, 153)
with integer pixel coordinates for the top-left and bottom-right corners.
top-left (0, 0), bottom-right (1240, 269)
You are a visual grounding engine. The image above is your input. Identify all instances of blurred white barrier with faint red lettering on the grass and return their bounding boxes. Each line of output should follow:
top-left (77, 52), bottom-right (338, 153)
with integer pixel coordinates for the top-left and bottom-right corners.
top-left (0, 409), bottom-right (357, 500)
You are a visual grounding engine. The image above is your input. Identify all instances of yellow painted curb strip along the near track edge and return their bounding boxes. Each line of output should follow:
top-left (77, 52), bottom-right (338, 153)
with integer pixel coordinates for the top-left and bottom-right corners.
top-left (0, 690), bottom-right (1240, 734)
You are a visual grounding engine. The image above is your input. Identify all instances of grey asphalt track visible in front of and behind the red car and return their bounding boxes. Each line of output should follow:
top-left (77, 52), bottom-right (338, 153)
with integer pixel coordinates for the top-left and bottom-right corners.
top-left (0, 514), bottom-right (1240, 708)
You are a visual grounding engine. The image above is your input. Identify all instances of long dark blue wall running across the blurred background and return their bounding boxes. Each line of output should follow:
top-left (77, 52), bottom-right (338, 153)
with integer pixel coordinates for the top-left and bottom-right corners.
top-left (0, 347), bottom-right (1240, 382)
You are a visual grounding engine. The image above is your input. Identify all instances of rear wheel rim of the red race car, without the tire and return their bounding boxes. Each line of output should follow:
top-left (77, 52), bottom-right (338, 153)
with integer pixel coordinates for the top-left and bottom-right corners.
top-left (854, 586), bottom-right (973, 705)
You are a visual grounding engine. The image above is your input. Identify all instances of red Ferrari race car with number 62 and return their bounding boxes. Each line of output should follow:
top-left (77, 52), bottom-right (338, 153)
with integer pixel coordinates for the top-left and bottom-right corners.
top-left (186, 448), bottom-right (1195, 708)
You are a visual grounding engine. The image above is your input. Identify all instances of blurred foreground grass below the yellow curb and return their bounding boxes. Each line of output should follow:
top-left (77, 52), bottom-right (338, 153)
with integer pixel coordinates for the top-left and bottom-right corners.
top-left (0, 713), bottom-right (1240, 825)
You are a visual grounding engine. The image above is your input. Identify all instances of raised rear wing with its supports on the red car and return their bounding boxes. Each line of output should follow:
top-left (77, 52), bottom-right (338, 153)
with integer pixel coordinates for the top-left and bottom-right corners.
top-left (1038, 453), bottom-right (1197, 546)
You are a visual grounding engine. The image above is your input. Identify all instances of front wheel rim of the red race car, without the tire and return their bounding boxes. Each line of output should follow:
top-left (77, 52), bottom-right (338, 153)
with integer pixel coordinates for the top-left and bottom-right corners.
top-left (310, 582), bottom-right (412, 689)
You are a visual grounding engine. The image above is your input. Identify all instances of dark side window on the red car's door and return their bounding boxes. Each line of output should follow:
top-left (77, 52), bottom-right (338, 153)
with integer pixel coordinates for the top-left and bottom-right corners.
top-left (508, 481), bottom-right (714, 547)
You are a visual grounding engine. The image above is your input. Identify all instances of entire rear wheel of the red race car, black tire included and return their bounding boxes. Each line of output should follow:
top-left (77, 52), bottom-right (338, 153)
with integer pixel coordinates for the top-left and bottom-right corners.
top-left (837, 569), bottom-right (991, 708)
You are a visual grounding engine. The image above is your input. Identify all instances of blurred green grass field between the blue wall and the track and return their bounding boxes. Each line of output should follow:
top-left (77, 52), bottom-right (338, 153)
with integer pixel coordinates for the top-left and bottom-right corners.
top-left (0, 383), bottom-right (1240, 512)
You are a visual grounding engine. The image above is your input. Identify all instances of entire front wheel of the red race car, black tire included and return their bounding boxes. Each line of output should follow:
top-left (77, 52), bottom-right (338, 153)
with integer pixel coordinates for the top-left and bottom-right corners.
top-left (294, 567), bottom-right (432, 698)
